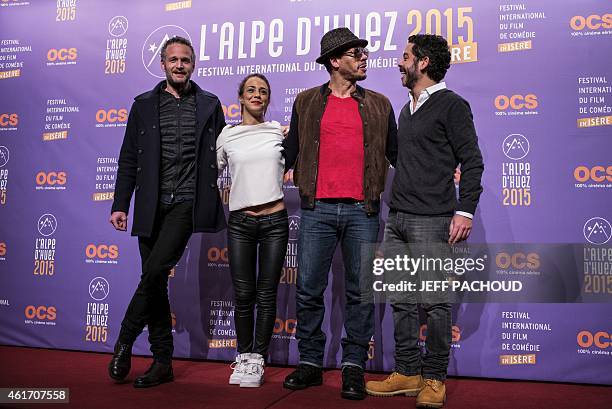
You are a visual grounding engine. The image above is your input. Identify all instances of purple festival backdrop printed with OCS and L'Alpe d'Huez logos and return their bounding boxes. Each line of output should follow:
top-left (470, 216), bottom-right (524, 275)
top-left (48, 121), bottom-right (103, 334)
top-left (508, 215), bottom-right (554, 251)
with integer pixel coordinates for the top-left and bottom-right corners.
top-left (0, 0), bottom-right (612, 384)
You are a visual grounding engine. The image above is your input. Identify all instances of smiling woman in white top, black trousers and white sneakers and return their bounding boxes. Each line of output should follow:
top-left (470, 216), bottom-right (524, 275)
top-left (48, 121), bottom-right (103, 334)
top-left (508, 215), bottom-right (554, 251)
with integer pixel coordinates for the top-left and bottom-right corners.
top-left (217, 74), bottom-right (289, 387)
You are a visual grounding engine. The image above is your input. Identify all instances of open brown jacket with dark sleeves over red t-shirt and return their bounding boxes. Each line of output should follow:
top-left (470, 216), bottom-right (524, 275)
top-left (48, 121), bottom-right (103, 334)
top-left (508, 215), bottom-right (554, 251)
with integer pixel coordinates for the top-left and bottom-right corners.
top-left (283, 83), bottom-right (397, 214)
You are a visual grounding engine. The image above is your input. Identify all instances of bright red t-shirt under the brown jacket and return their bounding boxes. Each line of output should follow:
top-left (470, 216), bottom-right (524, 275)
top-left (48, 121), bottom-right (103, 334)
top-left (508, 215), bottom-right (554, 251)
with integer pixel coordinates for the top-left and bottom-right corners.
top-left (315, 94), bottom-right (364, 200)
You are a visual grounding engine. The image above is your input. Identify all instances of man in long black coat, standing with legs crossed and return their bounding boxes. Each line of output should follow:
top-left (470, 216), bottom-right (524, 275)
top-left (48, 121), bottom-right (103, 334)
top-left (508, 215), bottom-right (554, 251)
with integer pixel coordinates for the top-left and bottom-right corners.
top-left (109, 37), bottom-right (225, 388)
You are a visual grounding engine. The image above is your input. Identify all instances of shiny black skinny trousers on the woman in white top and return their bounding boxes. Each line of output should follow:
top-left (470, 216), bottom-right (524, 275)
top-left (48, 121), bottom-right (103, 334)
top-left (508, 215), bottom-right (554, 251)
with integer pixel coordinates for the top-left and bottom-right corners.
top-left (227, 210), bottom-right (289, 358)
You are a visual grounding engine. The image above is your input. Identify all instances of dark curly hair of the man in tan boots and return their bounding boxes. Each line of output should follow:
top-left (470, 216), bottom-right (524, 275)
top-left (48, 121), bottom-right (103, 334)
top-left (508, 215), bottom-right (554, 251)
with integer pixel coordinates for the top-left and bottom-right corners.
top-left (408, 34), bottom-right (451, 82)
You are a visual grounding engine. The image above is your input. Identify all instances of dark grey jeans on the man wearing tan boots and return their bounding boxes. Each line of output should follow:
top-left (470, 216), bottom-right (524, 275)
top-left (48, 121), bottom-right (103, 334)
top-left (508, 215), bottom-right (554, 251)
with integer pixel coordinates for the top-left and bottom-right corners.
top-left (384, 211), bottom-right (452, 381)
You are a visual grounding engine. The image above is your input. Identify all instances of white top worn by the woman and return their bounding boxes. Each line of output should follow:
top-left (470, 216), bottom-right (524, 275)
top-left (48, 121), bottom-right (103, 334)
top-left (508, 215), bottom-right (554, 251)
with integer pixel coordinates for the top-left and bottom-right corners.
top-left (217, 121), bottom-right (285, 211)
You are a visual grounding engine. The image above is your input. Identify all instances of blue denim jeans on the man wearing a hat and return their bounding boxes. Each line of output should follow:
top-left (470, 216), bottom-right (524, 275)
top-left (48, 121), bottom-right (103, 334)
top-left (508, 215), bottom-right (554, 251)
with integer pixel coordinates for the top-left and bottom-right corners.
top-left (296, 201), bottom-right (379, 368)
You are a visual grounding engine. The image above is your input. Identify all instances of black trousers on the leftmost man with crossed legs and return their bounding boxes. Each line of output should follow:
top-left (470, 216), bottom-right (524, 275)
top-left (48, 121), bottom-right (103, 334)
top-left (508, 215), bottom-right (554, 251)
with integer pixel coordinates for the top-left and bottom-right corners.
top-left (119, 201), bottom-right (193, 364)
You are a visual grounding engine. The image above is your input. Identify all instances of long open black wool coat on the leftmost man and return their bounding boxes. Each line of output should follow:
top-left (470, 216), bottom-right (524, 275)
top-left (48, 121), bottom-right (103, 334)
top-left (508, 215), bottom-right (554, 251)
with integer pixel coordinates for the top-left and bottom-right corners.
top-left (111, 81), bottom-right (226, 237)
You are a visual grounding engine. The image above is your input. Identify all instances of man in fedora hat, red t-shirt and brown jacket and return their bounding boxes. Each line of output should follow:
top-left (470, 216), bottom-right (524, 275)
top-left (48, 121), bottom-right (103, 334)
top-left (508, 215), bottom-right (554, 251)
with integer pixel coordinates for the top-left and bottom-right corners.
top-left (283, 27), bottom-right (397, 399)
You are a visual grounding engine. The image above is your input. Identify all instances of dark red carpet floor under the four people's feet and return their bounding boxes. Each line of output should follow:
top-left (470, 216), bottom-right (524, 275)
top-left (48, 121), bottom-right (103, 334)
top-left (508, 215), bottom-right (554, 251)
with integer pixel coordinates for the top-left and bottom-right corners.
top-left (0, 347), bottom-right (612, 409)
